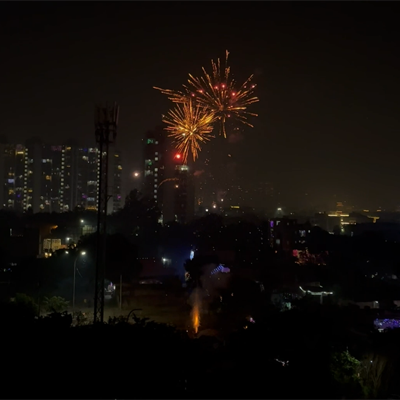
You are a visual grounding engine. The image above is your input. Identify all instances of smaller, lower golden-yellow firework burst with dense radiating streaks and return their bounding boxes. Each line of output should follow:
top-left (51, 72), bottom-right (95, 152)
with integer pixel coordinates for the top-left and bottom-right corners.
top-left (163, 100), bottom-right (215, 163)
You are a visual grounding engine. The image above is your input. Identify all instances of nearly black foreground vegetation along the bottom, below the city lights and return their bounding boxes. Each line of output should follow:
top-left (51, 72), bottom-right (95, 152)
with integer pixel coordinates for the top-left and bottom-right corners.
top-left (1, 308), bottom-right (399, 399)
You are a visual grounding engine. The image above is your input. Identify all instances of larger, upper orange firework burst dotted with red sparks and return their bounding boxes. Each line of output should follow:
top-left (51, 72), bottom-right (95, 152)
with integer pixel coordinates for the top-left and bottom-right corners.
top-left (155, 51), bottom-right (259, 137)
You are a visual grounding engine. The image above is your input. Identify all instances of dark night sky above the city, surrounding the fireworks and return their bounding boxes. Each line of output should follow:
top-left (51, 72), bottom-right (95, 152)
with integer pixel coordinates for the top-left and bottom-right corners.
top-left (0, 2), bottom-right (400, 208)
